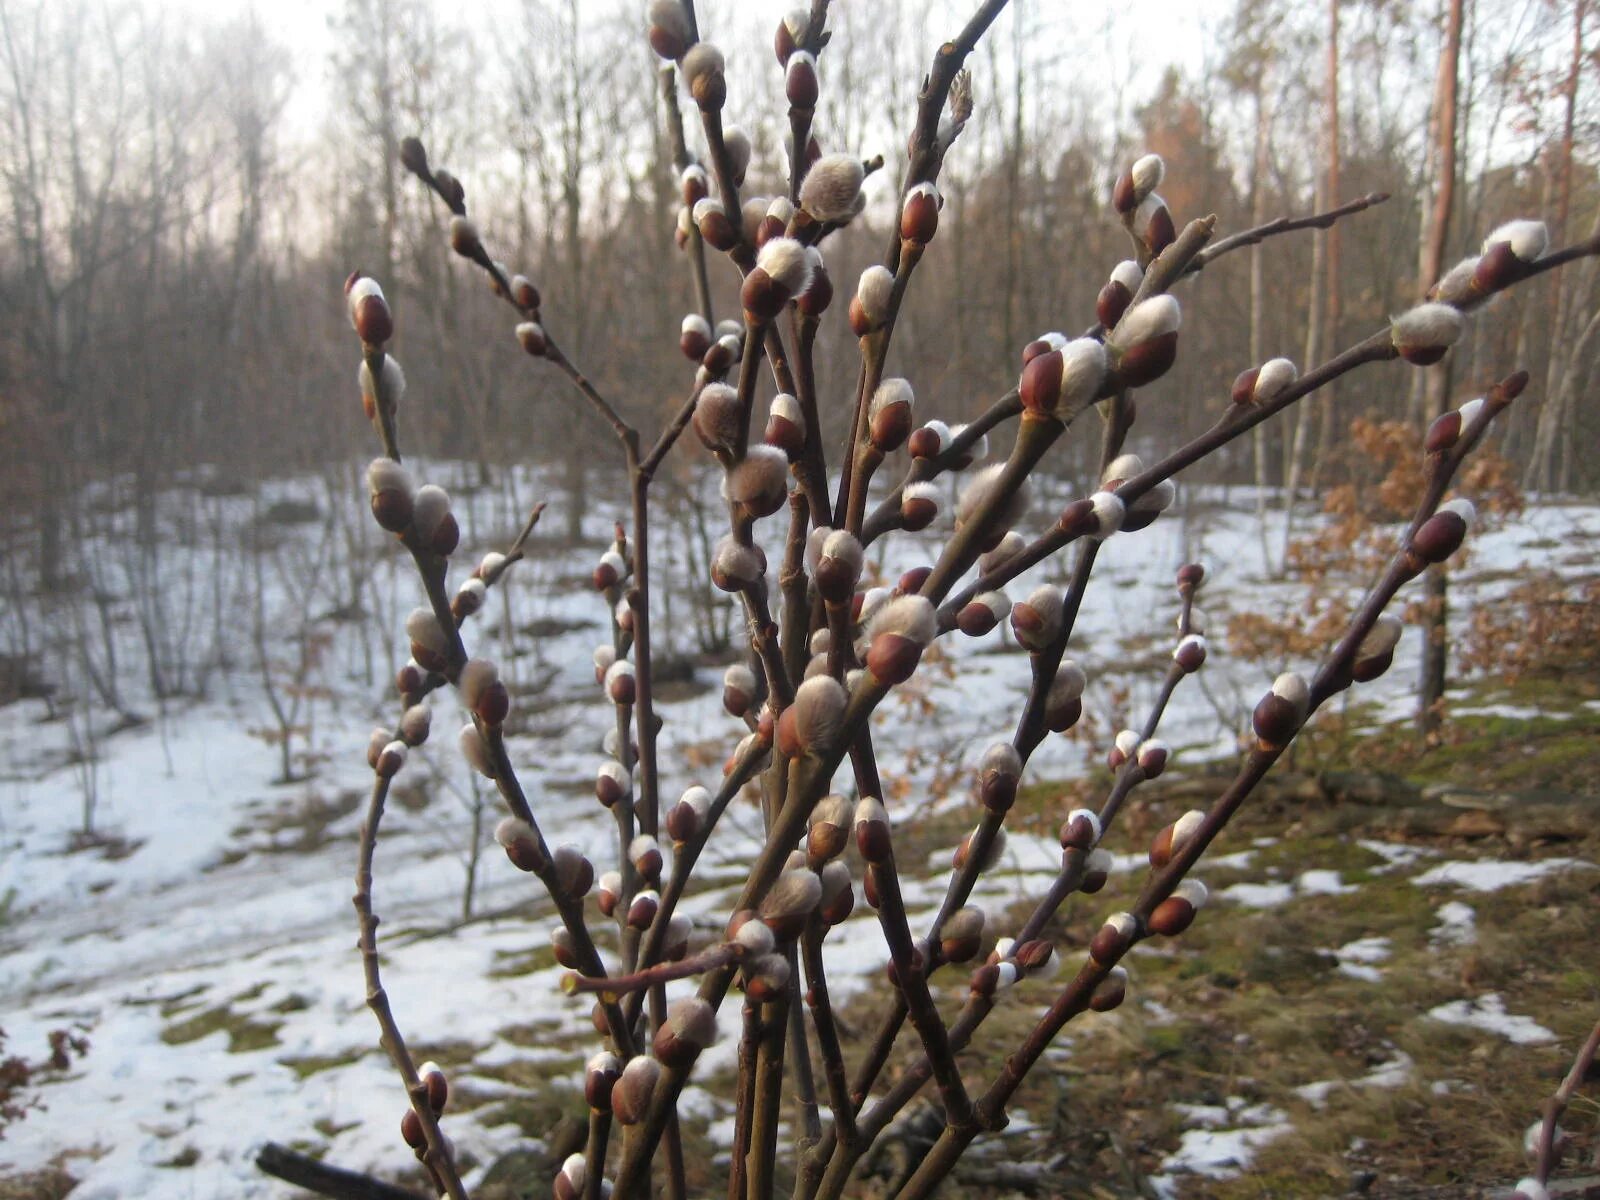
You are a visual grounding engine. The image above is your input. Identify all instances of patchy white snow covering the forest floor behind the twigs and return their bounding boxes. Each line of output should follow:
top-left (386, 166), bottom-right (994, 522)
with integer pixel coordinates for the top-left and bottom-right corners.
top-left (0, 464), bottom-right (1600, 1200)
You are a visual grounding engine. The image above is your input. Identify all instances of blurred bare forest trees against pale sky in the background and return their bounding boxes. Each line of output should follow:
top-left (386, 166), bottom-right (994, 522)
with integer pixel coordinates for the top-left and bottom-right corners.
top-left (0, 0), bottom-right (1600, 717)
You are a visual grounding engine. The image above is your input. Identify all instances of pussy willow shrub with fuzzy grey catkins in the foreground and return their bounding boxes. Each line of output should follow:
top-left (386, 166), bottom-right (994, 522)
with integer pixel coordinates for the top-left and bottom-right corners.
top-left (328, 0), bottom-right (1600, 1200)
